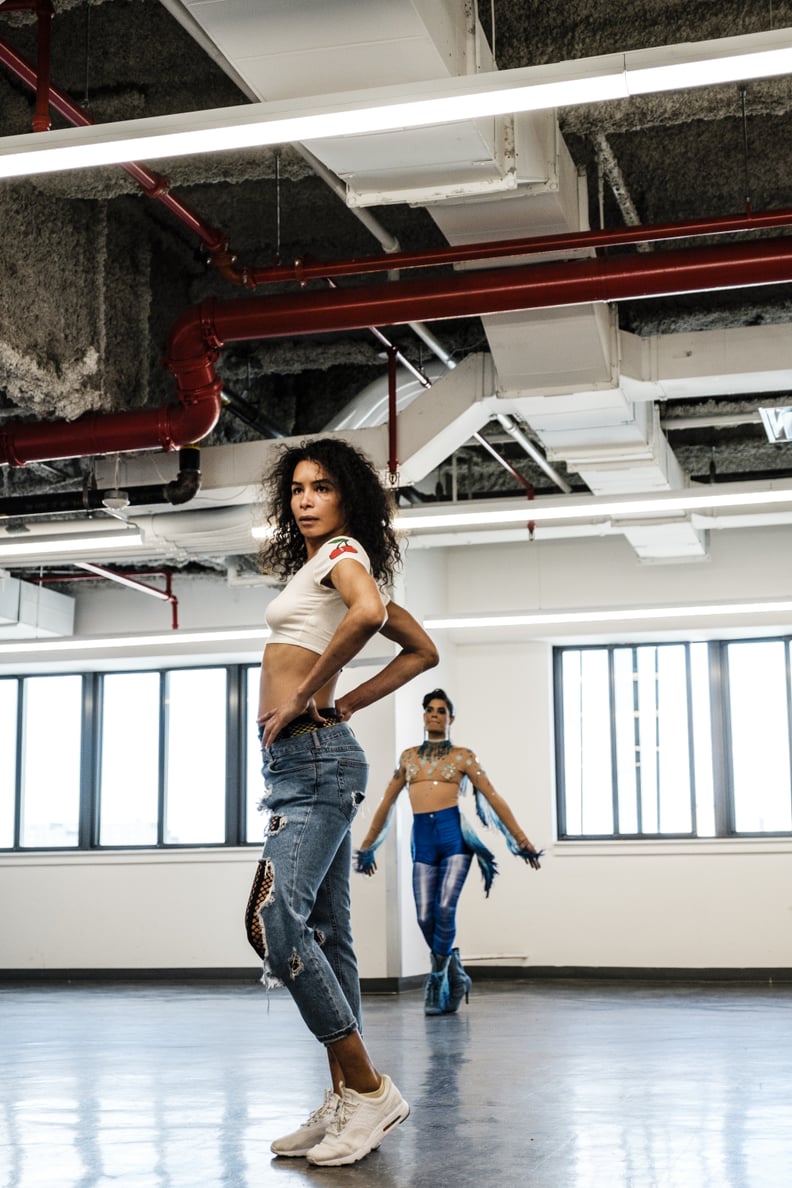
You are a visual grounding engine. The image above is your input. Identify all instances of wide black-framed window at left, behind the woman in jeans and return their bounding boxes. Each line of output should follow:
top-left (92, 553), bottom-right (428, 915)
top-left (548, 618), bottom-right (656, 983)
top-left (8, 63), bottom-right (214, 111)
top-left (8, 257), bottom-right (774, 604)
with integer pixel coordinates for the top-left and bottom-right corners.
top-left (0, 665), bottom-right (262, 849)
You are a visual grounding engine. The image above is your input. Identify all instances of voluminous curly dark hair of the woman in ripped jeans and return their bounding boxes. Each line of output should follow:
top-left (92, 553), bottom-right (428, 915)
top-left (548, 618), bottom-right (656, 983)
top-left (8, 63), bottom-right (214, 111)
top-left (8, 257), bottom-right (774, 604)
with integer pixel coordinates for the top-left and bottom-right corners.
top-left (259, 437), bottom-right (401, 584)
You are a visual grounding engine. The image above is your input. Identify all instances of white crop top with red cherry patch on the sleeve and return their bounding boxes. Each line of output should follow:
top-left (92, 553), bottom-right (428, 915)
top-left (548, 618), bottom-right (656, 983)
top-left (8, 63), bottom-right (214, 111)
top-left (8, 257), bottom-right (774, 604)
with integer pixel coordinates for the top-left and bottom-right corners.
top-left (266, 536), bottom-right (372, 655)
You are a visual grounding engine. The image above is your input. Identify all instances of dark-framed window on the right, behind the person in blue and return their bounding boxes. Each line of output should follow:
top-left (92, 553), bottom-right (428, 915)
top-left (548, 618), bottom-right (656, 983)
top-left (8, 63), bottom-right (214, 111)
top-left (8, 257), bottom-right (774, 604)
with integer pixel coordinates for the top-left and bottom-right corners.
top-left (556, 639), bottom-right (792, 838)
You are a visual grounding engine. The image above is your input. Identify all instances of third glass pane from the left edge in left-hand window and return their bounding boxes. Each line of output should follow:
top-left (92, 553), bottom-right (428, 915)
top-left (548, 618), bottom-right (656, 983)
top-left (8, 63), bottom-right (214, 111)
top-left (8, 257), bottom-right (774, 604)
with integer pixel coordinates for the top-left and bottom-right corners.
top-left (99, 672), bottom-right (159, 846)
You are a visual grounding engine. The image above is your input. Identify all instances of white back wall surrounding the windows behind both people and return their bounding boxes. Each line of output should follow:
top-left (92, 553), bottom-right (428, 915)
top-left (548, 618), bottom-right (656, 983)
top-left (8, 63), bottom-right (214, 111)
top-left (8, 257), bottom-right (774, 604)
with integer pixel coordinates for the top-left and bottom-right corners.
top-left (0, 529), bottom-right (792, 978)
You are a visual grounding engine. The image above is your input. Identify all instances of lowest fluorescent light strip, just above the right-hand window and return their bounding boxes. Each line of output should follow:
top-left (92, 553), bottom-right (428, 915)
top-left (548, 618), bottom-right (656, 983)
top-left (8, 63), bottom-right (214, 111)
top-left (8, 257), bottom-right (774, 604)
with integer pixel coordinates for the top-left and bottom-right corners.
top-left (424, 599), bottom-right (792, 631)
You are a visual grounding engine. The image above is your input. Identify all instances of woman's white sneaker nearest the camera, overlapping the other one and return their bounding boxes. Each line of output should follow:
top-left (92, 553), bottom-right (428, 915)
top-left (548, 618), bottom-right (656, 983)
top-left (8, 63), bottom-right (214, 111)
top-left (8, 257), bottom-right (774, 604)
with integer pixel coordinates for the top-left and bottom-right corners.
top-left (308, 1076), bottom-right (410, 1168)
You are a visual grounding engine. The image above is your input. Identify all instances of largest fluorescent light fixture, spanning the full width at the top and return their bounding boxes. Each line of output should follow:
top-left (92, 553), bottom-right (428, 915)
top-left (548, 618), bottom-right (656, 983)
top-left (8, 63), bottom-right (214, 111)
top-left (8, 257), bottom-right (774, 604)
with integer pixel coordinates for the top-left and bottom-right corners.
top-left (0, 29), bottom-right (792, 177)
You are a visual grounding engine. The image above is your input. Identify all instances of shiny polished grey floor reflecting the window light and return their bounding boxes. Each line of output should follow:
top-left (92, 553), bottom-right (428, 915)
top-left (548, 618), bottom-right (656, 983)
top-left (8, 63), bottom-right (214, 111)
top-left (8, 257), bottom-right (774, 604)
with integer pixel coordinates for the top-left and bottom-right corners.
top-left (0, 980), bottom-right (792, 1188)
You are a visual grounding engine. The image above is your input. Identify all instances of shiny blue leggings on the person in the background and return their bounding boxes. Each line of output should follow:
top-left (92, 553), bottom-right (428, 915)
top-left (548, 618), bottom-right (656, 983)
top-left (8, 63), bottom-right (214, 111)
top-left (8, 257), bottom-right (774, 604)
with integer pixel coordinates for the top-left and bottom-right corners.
top-left (412, 807), bottom-right (473, 956)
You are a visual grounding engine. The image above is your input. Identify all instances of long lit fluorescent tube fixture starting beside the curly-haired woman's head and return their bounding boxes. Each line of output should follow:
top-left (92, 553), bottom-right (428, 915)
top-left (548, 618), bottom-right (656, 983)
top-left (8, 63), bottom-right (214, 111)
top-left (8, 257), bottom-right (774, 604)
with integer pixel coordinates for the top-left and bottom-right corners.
top-left (395, 484), bottom-right (792, 532)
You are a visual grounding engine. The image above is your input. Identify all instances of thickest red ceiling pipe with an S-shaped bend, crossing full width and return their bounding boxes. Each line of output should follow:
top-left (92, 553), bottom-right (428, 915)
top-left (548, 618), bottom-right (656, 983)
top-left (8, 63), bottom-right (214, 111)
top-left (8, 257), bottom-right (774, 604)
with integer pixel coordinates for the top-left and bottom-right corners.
top-left (0, 231), bottom-right (792, 466)
